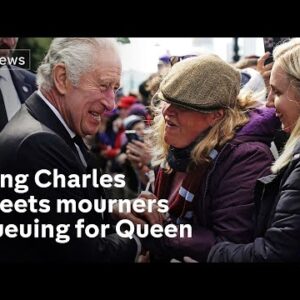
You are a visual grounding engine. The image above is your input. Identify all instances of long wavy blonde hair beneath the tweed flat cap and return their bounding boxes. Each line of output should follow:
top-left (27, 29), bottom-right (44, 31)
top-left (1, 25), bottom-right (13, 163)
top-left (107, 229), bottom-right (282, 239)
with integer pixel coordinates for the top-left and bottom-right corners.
top-left (149, 88), bottom-right (261, 172)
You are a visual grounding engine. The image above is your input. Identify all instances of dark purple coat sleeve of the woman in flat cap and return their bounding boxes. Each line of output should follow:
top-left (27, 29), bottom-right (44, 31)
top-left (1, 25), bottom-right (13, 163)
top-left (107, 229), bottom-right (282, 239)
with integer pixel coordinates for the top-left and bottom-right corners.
top-left (146, 142), bottom-right (273, 261)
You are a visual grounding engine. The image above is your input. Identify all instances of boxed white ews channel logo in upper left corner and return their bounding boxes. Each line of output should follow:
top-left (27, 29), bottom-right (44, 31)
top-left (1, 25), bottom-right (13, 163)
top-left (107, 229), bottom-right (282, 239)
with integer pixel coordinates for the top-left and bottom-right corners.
top-left (0, 49), bottom-right (31, 70)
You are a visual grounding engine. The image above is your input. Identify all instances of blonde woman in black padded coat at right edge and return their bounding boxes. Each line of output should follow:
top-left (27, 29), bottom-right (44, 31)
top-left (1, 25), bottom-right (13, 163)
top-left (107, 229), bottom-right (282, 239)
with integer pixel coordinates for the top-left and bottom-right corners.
top-left (208, 38), bottom-right (300, 262)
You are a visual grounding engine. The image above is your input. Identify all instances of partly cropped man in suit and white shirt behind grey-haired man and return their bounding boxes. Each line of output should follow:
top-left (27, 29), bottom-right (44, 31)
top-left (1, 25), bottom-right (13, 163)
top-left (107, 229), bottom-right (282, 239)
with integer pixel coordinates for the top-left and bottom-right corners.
top-left (0, 37), bottom-right (36, 132)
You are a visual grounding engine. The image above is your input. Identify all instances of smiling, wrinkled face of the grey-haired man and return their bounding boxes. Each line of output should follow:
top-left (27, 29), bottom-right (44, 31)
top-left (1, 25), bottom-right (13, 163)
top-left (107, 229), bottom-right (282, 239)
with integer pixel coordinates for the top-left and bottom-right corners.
top-left (61, 50), bottom-right (121, 136)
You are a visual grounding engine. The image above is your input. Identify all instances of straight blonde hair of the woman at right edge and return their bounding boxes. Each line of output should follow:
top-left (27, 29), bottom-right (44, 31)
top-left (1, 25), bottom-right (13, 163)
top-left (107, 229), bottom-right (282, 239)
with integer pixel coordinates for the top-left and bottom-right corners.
top-left (272, 38), bottom-right (300, 173)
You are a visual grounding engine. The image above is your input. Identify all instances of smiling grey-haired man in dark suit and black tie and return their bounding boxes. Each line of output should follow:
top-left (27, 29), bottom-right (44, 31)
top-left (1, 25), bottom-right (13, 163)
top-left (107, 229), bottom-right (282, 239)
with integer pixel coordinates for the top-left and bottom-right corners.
top-left (0, 38), bottom-right (140, 262)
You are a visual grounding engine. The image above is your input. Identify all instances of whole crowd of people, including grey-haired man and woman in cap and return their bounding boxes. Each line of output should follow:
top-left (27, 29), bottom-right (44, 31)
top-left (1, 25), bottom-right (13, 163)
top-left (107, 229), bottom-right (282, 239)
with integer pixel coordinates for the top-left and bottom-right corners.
top-left (0, 38), bottom-right (300, 263)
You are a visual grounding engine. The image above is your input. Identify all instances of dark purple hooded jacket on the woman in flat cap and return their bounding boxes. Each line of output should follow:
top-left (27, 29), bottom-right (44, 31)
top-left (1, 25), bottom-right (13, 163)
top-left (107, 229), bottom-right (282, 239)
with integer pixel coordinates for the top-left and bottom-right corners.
top-left (144, 109), bottom-right (279, 261)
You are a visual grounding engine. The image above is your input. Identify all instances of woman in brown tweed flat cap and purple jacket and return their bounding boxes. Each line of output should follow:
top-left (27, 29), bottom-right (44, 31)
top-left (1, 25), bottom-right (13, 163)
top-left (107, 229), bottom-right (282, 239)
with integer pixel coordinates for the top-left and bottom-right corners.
top-left (114, 54), bottom-right (279, 262)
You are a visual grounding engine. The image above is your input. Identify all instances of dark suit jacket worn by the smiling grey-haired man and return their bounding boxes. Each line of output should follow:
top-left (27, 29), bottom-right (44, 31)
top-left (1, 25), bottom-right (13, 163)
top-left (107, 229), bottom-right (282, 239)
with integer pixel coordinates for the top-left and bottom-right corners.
top-left (0, 93), bottom-right (137, 262)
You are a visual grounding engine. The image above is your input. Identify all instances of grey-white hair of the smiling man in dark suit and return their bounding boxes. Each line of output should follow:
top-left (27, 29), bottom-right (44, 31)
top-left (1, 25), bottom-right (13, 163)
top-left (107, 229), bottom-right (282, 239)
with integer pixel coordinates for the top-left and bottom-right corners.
top-left (37, 38), bottom-right (118, 91)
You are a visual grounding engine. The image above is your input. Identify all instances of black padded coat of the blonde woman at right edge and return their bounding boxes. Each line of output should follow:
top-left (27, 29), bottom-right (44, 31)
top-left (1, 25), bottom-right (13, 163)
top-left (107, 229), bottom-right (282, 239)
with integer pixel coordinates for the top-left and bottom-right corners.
top-left (208, 142), bottom-right (300, 262)
